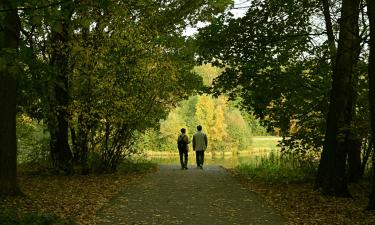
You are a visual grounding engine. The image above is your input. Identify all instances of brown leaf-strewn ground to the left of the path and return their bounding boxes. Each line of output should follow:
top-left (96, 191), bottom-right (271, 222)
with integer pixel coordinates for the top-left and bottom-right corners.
top-left (0, 164), bottom-right (156, 225)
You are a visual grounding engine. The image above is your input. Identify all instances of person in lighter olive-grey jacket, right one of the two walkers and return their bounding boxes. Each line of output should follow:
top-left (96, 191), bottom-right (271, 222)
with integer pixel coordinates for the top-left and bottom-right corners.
top-left (193, 125), bottom-right (208, 169)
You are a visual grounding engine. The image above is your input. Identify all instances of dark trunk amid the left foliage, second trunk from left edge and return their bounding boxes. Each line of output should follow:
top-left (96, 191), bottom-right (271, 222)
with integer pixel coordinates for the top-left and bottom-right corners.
top-left (49, 3), bottom-right (73, 173)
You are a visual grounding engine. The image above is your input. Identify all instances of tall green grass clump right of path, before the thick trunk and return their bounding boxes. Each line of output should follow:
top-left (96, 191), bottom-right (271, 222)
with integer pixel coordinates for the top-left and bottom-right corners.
top-left (235, 151), bottom-right (316, 183)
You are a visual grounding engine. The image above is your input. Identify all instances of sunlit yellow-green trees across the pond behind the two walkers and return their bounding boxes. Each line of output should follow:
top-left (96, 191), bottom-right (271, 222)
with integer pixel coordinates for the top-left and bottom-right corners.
top-left (136, 96), bottom-right (262, 154)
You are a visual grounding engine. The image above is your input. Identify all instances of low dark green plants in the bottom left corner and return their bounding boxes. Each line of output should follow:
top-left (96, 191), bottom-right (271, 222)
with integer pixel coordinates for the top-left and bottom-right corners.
top-left (0, 210), bottom-right (76, 225)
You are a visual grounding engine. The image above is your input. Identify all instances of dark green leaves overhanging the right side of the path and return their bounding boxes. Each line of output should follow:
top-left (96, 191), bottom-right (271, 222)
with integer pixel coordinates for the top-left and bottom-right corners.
top-left (197, 0), bottom-right (369, 167)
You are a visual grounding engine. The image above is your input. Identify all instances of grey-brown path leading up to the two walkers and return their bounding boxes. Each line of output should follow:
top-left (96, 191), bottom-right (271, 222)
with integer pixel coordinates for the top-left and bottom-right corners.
top-left (97, 165), bottom-right (286, 225)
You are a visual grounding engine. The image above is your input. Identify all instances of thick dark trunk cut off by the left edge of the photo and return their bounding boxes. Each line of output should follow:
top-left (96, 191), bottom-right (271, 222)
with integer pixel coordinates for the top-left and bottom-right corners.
top-left (0, 0), bottom-right (21, 195)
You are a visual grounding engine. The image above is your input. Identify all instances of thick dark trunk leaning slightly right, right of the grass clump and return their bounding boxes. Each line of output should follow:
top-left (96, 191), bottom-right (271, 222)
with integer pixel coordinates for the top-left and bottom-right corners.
top-left (315, 0), bottom-right (360, 197)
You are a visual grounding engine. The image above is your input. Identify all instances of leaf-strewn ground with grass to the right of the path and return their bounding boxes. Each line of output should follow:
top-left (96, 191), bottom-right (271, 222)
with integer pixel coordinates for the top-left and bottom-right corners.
top-left (234, 160), bottom-right (375, 225)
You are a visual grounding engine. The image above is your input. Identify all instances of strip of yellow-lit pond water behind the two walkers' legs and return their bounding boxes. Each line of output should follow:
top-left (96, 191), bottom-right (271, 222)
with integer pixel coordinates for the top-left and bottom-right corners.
top-left (147, 152), bottom-right (269, 168)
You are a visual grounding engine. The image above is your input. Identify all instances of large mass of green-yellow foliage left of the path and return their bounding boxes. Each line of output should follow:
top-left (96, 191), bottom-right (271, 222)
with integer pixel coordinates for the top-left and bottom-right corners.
top-left (12, 0), bottom-right (232, 171)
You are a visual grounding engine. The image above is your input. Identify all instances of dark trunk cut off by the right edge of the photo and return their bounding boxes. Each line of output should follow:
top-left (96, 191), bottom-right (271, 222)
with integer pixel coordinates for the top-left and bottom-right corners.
top-left (367, 0), bottom-right (375, 210)
